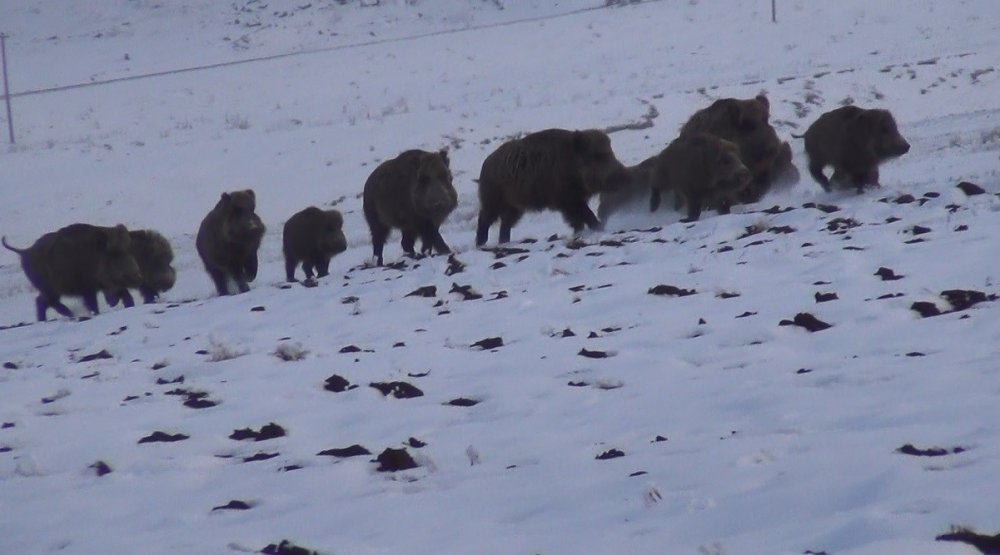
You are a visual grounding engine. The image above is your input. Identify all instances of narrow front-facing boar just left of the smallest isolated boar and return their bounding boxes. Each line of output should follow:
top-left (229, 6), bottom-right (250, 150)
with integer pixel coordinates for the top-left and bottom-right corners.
top-left (195, 189), bottom-right (266, 295)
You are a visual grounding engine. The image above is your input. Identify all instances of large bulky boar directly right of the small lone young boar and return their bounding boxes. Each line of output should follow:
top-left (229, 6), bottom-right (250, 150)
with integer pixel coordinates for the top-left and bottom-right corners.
top-left (362, 150), bottom-right (458, 266)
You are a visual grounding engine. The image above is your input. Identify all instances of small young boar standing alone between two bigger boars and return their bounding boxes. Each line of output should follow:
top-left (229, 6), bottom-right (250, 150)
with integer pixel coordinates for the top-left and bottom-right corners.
top-left (281, 206), bottom-right (347, 281)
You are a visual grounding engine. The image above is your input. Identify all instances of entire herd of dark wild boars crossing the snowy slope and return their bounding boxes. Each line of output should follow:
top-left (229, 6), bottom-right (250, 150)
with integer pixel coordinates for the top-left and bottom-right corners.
top-left (2, 95), bottom-right (910, 321)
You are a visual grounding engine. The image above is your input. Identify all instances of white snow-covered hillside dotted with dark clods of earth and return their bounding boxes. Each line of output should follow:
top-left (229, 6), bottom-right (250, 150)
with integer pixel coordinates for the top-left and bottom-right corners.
top-left (0, 0), bottom-right (1000, 555)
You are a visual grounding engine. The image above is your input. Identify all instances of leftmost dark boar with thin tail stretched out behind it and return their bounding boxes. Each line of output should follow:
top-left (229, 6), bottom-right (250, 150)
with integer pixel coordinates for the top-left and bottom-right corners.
top-left (2, 224), bottom-right (142, 322)
